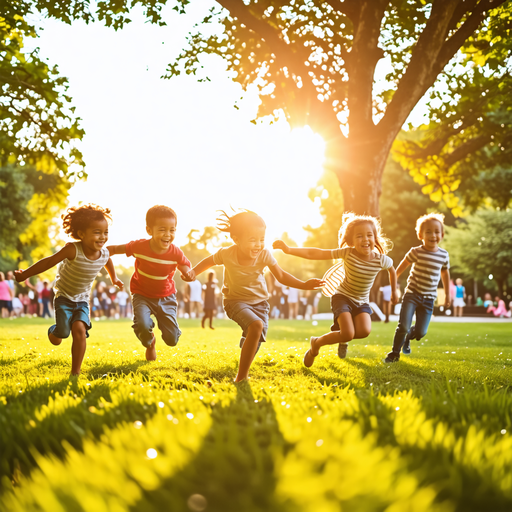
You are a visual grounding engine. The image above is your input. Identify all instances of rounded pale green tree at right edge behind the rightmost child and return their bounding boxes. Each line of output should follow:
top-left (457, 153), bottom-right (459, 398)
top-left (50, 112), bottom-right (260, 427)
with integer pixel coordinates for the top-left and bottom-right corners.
top-left (446, 210), bottom-right (512, 295)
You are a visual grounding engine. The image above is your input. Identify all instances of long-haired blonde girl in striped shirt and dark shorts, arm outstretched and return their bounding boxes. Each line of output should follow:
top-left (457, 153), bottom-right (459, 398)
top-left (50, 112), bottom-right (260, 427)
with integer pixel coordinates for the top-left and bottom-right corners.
top-left (273, 212), bottom-right (397, 368)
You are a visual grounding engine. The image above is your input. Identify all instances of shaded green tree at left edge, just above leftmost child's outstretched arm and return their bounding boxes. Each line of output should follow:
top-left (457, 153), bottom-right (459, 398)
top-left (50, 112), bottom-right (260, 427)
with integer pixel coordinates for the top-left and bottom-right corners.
top-left (0, 166), bottom-right (71, 270)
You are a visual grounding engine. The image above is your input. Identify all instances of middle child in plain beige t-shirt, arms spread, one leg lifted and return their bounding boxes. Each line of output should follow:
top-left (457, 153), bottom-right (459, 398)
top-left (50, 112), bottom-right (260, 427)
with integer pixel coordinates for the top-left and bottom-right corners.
top-left (183, 210), bottom-right (323, 382)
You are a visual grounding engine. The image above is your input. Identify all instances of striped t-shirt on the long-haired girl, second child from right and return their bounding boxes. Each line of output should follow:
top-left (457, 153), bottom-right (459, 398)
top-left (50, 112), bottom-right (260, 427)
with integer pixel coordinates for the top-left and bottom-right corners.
top-left (331, 247), bottom-right (393, 305)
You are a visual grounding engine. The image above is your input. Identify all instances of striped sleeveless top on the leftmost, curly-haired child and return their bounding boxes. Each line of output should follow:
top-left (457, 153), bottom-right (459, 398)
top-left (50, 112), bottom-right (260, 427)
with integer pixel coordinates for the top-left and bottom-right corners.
top-left (54, 242), bottom-right (109, 302)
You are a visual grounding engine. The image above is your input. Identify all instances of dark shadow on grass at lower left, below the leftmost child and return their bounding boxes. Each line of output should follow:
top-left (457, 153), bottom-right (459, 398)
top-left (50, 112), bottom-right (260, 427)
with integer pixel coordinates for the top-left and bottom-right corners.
top-left (0, 378), bottom-right (157, 491)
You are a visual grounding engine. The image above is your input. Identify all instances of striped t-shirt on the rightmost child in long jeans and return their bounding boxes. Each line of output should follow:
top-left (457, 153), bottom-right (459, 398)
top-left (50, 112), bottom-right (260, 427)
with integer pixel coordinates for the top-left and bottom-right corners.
top-left (405, 245), bottom-right (450, 299)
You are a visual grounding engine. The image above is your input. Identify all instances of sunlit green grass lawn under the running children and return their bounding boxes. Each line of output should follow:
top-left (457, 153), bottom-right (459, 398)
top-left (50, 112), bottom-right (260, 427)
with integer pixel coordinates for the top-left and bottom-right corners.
top-left (0, 319), bottom-right (512, 512)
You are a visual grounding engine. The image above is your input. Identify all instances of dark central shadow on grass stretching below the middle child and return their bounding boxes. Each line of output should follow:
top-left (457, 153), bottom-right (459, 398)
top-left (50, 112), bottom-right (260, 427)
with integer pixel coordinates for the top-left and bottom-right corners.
top-left (130, 383), bottom-right (296, 512)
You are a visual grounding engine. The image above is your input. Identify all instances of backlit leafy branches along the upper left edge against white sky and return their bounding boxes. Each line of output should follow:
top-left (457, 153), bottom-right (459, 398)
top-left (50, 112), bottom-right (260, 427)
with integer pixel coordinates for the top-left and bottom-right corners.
top-left (0, 10), bottom-right (85, 177)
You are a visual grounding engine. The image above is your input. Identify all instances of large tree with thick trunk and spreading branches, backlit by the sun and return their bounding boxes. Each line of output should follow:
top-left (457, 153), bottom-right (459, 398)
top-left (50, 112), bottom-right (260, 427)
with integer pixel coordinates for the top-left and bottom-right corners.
top-left (167, 0), bottom-right (512, 215)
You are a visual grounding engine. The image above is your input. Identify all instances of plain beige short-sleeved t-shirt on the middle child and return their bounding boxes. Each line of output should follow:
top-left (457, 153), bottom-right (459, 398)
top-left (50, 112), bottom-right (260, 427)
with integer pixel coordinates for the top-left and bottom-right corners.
top-left (213, 245), bottom-right (277, 304)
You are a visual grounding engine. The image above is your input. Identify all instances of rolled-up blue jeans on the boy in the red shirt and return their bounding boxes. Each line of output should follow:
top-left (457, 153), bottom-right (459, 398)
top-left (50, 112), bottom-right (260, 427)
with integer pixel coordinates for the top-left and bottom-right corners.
top-left (132, 293), bottom-right (181, 347)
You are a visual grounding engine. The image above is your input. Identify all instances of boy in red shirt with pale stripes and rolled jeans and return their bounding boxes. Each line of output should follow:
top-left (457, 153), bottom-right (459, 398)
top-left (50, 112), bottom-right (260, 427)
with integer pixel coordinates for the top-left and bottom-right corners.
top-left (108, 205), bottom-right (191, 361)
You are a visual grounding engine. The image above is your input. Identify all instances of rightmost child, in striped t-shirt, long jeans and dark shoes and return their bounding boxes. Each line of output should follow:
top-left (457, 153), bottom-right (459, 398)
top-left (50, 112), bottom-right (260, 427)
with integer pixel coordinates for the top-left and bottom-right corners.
top-left (384, 213), bottom-right (450, 363)
